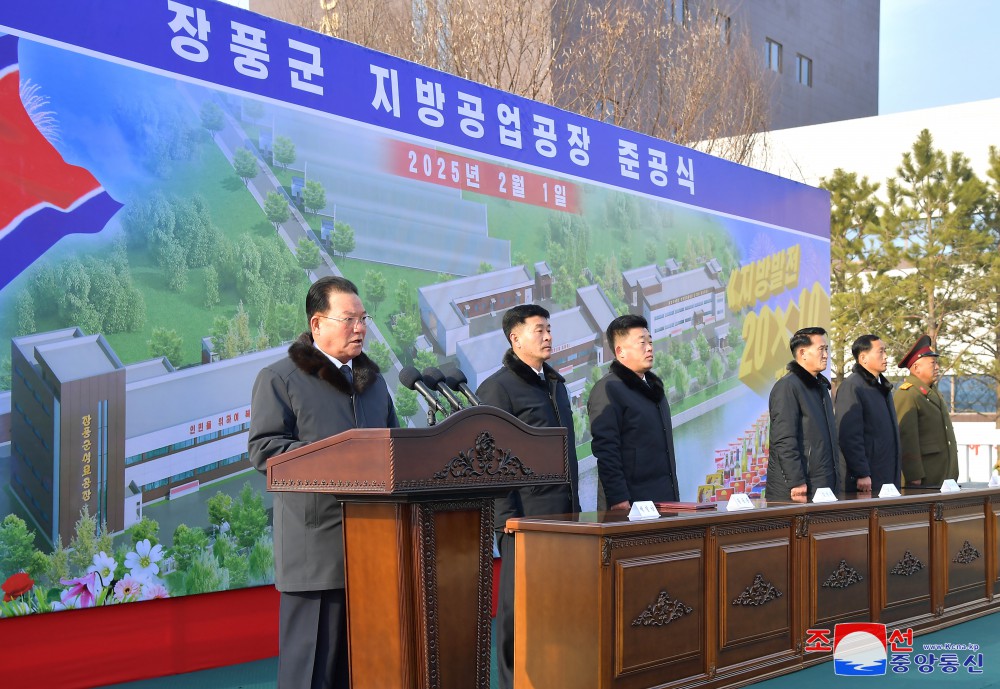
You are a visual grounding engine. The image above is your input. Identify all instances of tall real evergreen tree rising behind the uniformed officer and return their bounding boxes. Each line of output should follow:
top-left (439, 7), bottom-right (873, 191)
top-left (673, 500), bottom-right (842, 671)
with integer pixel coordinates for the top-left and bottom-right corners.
top-left (882, 129), bottom-right (990, 360)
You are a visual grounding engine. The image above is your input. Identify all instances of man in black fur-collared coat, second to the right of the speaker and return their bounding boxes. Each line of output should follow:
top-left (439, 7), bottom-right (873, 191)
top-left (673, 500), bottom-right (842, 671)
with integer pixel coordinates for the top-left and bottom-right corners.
top-left (587, 315), bottom-right (679, 510)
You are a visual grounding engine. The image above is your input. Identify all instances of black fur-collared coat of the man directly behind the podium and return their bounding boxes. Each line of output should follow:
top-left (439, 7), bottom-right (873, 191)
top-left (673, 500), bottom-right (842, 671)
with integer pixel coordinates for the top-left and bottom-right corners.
top-left (476, 349), bottom-right (580, 531)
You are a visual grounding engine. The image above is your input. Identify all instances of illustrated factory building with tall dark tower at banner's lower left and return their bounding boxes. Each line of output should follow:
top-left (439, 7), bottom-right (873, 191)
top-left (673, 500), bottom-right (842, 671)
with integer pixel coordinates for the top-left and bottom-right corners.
top-left (9, 328), bottom-right (286, 542)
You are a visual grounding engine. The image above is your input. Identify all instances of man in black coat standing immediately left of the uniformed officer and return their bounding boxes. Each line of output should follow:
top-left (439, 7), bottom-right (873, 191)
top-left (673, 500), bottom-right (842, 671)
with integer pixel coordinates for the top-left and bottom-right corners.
top-left (834, 335), bottom-right (902, 493)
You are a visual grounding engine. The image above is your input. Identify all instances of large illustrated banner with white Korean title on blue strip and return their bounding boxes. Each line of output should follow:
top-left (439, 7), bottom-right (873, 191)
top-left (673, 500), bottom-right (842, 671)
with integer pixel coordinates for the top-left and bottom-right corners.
top-left (0, 0), bottom-right (830, 624)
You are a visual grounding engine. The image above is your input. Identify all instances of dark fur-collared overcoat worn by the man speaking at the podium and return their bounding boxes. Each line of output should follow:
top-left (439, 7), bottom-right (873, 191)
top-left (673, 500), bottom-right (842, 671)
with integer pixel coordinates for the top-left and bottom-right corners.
top-left (248, 333), bottom-right (398, 592)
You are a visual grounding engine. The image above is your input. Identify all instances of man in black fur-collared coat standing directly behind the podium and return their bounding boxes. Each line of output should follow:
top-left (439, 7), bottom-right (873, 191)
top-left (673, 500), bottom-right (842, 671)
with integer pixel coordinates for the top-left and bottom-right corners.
top-left (476, 304), bottom-right (580, 689)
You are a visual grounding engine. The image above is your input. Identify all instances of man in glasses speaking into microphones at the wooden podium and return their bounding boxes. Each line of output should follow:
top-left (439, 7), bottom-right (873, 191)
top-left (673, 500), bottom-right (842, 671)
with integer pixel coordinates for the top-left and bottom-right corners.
top-left (249, 277), bottom-right (398, 689)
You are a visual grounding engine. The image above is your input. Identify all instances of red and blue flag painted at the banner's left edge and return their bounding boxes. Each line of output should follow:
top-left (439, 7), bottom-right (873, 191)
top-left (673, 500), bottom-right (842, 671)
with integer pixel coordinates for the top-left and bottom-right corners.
top-left (0, 35), bottom-right (122, 289)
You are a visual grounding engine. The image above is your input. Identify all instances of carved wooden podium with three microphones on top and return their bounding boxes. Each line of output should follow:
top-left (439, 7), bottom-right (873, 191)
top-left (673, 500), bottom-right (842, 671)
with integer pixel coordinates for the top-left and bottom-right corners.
top-left (267, 406), bottom-right (568, 689)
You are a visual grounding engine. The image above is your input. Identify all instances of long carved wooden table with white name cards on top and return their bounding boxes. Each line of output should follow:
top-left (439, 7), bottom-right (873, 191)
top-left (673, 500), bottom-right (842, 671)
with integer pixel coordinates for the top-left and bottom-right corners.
top-left (508, 486), bottom-right (1000, 689)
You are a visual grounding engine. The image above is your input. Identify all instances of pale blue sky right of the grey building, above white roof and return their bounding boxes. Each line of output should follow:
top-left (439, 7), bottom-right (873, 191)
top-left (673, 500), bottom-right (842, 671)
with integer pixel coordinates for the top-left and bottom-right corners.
top-left (878, 0), bottom-right (1000, 115)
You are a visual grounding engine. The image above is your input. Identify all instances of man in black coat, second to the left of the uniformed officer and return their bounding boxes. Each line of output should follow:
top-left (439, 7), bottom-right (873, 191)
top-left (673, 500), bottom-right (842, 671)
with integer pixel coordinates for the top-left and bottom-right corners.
top-left (765, 327), bottom-right (845, 502)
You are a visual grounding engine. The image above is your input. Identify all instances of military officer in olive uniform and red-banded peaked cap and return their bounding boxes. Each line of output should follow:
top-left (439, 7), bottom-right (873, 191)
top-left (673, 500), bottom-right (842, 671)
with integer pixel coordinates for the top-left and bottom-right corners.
top-left (894, 335), bottom-right (958, 487)
